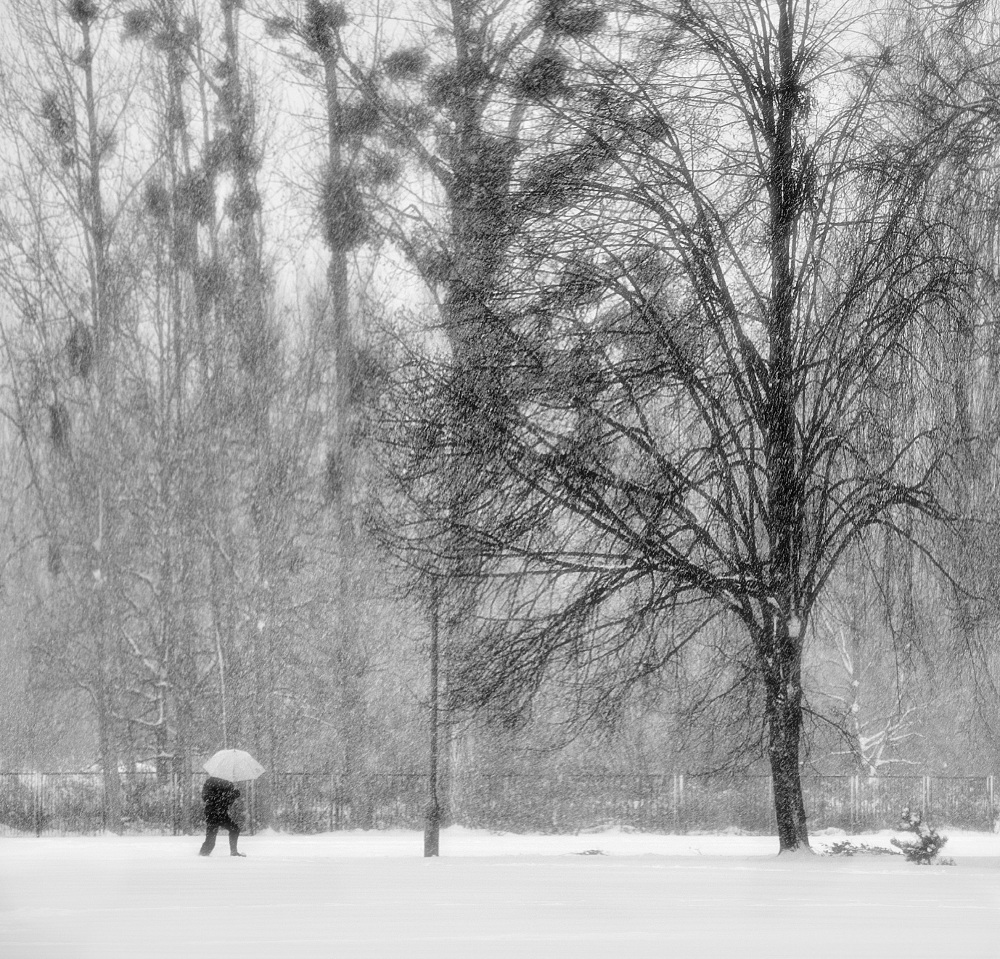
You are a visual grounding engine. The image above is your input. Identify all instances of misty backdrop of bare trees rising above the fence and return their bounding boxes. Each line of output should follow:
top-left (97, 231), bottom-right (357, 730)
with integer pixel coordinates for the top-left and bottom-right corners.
top-left (0, 0), bottom-right (1000, 848)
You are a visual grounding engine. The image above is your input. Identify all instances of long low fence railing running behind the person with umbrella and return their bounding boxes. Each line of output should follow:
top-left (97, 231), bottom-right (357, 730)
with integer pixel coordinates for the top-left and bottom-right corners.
top-left (0, 772), bottom-right (1000, 836)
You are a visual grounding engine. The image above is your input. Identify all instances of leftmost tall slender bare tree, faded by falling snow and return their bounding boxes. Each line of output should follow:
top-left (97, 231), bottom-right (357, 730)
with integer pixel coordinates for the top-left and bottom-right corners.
top-left (5, 0), bottom-right (160, 829)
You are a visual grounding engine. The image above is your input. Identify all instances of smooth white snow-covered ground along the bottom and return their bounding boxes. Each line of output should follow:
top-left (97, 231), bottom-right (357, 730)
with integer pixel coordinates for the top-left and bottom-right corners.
top-left (0, 829), bottom-right (1000, 959)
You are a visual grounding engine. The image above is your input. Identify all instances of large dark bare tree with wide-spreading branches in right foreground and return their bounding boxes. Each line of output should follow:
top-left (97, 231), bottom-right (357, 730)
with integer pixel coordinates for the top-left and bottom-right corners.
top-left (380, 0), bottom-right (984, 851)
